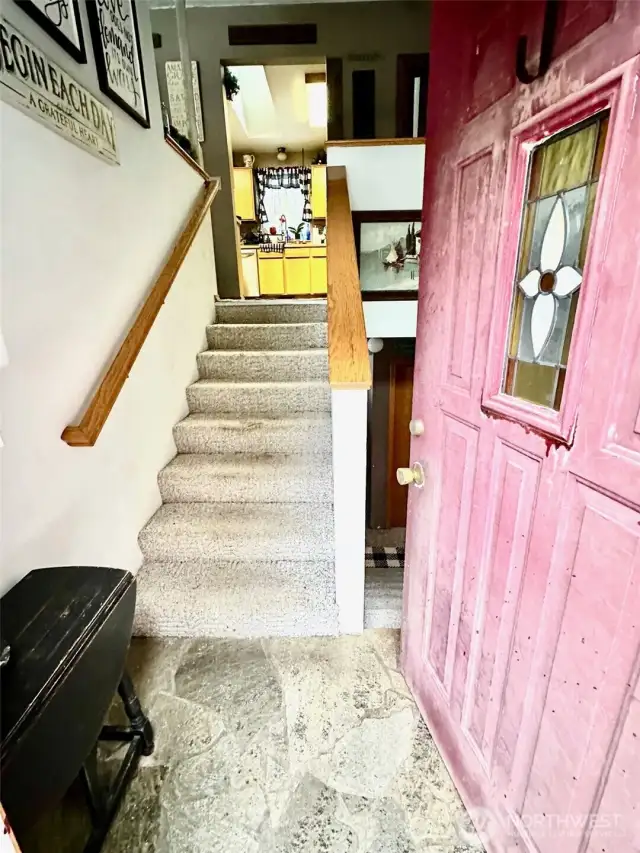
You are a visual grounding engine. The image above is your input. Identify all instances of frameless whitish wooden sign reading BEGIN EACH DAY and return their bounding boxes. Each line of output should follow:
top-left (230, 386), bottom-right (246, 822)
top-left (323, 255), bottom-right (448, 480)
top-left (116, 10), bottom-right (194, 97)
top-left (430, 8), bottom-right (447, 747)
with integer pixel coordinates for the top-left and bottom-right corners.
top-left (0, 18), bottom-right (118, 164)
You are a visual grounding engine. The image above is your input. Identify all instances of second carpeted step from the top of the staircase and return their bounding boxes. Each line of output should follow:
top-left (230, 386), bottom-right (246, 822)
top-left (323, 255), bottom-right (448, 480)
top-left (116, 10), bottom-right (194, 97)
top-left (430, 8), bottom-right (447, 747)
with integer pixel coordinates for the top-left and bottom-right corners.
top-left (207, 323), bottom-right (327, 350)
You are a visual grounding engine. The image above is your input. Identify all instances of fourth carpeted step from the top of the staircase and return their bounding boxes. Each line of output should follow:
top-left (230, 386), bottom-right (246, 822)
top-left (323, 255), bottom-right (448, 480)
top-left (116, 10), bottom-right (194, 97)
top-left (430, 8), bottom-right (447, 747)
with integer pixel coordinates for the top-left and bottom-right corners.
top-left (187, 379), bottom-right (331, 416)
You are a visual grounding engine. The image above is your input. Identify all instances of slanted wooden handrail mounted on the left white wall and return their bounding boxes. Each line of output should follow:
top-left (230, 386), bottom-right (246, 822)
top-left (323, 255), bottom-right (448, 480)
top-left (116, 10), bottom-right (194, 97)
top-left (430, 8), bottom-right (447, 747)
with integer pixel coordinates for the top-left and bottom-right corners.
top-left (61, 169), bottom-right (220, 447)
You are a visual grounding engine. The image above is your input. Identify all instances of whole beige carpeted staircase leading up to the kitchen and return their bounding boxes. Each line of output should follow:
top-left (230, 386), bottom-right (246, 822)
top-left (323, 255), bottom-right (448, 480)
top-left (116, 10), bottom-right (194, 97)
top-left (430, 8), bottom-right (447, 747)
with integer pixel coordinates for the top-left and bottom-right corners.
top-left (135, 300), bottom-right (337, 637)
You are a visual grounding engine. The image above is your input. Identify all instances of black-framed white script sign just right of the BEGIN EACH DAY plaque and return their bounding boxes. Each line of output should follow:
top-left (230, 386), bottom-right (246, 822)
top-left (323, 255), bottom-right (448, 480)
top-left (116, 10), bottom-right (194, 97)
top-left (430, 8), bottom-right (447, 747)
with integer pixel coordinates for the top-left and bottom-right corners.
top-left (87, 0), bottom-right (150, 127)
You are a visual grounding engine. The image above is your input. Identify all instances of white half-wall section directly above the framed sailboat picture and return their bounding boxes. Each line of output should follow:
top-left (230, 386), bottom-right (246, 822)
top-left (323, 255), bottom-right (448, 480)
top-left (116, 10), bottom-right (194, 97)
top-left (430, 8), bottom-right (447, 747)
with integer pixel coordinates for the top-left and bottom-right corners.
top-left (327, 143), bottom-right (425, 210)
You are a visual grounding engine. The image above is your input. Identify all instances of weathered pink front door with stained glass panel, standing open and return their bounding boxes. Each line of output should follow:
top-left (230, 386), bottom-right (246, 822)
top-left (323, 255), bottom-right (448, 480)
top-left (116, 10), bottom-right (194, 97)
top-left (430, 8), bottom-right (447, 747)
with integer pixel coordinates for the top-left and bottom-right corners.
top-left (403, 0), bottom-right (640, 853)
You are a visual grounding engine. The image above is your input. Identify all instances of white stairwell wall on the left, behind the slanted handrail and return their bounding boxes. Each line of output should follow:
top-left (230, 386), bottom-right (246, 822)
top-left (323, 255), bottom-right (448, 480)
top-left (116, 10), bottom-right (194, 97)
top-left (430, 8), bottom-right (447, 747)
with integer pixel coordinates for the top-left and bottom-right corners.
top-left (0, 3), bottom-right (215, 591)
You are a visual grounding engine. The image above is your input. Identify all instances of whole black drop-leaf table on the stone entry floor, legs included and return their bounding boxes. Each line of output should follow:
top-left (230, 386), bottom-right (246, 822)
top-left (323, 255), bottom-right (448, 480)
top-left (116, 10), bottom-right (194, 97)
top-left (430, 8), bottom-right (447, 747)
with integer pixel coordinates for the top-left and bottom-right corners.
top-left (0, 566), bottom-right (153, 853)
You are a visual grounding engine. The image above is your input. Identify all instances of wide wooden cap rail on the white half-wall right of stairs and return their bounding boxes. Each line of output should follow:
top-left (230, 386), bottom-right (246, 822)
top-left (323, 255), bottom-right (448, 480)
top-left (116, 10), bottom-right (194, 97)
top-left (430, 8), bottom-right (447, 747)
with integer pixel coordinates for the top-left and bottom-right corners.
top-left (327, 166), bottom-right (371, 389)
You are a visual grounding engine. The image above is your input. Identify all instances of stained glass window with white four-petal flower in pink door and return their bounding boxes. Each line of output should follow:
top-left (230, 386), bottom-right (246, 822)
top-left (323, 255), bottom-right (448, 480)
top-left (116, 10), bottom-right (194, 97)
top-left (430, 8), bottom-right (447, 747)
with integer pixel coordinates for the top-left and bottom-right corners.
top-left (503, 113), bottom-right (609, 410)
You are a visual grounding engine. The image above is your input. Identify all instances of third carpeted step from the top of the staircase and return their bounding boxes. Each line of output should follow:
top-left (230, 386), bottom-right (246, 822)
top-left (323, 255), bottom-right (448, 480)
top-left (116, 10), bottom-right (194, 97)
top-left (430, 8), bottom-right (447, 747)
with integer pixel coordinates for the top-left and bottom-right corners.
top-left (198, 349), bottom-right (329, 382)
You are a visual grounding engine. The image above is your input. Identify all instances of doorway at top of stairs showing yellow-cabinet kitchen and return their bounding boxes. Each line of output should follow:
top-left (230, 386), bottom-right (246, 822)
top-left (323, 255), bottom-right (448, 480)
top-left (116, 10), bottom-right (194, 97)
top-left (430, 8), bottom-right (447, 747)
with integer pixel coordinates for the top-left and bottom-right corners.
top-left (223, 60), bottom-right (327, 298)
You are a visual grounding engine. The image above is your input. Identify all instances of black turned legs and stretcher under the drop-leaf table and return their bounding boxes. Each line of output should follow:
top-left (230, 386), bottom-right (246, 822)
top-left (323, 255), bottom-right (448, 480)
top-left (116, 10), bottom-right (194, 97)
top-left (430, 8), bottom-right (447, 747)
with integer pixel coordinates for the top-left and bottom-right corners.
top-left (80, 672), bottom-right (154, 853)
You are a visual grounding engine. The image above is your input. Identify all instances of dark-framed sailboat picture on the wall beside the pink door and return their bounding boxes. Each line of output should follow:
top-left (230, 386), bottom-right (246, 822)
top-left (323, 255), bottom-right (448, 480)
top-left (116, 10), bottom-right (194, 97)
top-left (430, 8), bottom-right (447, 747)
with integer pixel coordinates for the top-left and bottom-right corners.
top-left (353, 210), bottom-right (422, 299)
